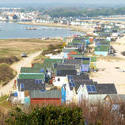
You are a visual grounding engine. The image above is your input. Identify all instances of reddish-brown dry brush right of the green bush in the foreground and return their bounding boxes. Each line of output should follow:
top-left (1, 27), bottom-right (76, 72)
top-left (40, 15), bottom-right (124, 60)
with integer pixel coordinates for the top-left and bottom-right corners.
top-left (80, 101), bottom-right (125, 125)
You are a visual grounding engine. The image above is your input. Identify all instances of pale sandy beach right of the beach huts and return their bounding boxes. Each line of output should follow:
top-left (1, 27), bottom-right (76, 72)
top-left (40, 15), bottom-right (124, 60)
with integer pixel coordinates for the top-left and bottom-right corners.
top-left (91, 36), bottom-right (125, 94)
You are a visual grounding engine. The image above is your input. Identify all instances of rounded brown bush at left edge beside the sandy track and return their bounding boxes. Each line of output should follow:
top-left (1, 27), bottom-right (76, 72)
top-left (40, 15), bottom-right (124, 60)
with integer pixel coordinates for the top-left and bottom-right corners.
top-left (0, 64), bottom-right (16, 85)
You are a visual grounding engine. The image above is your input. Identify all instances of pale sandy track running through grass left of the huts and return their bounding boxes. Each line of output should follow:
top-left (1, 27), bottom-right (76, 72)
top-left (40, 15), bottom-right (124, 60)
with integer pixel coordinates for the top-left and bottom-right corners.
top-left (0, 51), bottom-right (41, 97)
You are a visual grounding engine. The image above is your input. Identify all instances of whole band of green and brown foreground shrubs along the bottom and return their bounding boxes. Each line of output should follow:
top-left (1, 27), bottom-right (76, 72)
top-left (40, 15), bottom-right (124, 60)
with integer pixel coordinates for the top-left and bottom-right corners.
top-left (0, 101), bottom-right (125, 125)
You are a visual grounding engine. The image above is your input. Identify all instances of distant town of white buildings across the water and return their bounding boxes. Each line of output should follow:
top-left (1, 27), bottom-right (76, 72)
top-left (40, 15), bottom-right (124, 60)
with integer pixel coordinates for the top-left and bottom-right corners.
top-left (0, 8), bottom-right (125, 25)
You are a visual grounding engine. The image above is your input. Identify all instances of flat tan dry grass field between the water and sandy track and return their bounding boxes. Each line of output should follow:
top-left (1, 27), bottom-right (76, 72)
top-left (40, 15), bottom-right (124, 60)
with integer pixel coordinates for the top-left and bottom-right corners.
top-left (0, 39), bottom-right (61, 57)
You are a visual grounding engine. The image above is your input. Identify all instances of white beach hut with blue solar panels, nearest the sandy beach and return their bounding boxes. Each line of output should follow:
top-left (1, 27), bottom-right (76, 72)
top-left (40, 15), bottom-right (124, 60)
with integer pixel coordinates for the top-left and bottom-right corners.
top-left (77, 83), bottom-right (117, 104)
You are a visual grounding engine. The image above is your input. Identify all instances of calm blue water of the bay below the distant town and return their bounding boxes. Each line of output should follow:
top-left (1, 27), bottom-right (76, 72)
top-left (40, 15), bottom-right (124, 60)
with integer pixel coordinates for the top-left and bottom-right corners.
top-left (0, 22), bottom-right (81, 39)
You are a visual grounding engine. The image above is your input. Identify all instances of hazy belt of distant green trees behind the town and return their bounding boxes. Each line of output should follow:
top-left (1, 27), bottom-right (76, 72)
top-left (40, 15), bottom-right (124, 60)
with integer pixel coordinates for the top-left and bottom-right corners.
top-left (44, 8), bottom-right (125, 17)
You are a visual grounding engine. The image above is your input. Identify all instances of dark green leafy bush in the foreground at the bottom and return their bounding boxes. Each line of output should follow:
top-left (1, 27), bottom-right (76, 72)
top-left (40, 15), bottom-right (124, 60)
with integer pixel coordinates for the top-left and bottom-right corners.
top-left (6, 106), bottom-right (84, 125)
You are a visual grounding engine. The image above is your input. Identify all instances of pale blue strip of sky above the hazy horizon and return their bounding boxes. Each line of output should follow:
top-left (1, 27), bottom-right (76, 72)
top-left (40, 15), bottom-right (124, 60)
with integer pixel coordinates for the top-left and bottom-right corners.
top-left (0, 0), bottom-right (125, 7)
